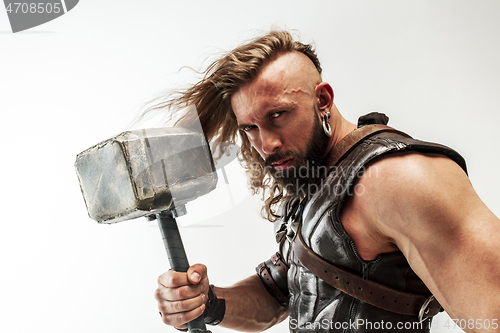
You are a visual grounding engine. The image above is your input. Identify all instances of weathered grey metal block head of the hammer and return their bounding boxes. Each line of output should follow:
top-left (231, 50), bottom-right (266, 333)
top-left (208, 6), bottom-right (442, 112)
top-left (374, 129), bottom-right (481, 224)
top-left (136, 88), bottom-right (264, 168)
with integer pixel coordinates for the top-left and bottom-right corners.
top-left (75, 127), bottom-right (217, 223)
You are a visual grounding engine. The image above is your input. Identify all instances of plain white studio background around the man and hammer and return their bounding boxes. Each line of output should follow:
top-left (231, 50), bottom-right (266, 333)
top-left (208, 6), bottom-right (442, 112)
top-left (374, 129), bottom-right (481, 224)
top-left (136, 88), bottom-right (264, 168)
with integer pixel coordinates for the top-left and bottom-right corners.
top-left (0, 0), bottom-right (500, 333)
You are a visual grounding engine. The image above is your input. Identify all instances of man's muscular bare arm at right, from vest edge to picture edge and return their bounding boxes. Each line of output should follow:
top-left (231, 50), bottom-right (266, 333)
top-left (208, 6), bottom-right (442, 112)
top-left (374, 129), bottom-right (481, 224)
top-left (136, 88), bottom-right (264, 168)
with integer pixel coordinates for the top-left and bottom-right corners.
top-left (364, 154), bottom-right (500, 319)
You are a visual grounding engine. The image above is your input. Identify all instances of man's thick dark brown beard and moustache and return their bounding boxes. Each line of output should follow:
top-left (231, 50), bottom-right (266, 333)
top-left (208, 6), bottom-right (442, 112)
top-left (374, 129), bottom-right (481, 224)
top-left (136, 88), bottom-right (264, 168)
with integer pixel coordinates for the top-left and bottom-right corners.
top-left (265, 114), bottom-right (329, 198)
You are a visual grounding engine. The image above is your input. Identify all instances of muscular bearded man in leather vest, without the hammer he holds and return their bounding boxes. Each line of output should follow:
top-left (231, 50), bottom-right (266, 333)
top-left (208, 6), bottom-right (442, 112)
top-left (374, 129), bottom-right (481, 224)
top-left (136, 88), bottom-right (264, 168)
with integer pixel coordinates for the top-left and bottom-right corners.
top-left (155, 31), bottom-right (500, 332)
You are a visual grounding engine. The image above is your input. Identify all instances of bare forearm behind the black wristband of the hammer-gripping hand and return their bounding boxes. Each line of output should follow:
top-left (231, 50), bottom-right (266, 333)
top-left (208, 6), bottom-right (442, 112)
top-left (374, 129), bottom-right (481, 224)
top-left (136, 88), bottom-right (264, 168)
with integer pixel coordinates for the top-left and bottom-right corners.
top-left (215, 275), bottom-right (288, 332)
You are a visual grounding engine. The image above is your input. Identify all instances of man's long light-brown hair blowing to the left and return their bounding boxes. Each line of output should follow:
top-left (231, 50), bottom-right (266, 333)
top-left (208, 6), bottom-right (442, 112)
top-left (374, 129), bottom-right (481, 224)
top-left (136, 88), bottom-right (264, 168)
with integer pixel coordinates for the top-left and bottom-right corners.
top-left (143, 30), bottom-right (321, 221)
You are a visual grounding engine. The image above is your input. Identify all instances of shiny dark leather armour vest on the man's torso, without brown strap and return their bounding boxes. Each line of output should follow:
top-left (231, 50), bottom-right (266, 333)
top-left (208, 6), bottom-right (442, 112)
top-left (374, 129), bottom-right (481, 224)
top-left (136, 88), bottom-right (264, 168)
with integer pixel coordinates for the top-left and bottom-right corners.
top-left (273, 128), bottom-right (466, 333)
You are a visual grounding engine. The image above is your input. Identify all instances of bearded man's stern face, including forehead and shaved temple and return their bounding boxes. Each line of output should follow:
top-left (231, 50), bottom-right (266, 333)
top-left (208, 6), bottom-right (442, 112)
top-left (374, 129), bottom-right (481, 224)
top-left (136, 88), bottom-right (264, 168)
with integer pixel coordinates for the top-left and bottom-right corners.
top-left (231, 53), bottom-right (329, 193)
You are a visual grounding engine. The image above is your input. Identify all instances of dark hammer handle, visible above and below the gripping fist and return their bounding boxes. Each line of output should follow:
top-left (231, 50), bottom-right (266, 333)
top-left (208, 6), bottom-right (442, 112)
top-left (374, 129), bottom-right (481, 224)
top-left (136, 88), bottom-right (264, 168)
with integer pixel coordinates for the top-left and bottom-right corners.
top-left (156, 210), bottom-right (210, 333)
